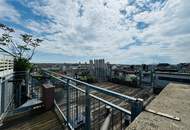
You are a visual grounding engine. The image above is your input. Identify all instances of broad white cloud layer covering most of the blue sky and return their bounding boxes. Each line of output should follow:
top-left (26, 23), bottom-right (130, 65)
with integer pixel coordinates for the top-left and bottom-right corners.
top-left (19, 0), bottom-right (190, 63)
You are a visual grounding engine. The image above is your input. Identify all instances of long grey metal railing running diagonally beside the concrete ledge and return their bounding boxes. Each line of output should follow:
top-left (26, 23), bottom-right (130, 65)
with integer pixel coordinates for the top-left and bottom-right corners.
top-left (43, 70), bottom-right (143, 130)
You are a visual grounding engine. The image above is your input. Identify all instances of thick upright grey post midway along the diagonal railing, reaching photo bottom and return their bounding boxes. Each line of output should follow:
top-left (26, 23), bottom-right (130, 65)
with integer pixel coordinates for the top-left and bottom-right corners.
top-left (85, 86), bottom-right (91, 130)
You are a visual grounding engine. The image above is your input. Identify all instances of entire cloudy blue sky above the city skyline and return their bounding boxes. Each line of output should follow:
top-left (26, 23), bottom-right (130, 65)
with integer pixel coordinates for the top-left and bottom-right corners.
top-left (0, 0), bottom-right (190, 64)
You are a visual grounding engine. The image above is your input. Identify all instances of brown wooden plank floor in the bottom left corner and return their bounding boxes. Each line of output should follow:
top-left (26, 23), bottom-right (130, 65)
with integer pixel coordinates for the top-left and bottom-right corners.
top-left (0, 111), bottom-right (63, 130)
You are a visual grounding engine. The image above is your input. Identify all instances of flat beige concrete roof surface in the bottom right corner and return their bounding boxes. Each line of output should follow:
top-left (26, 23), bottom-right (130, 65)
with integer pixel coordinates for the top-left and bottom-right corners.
top-left (126, 83), bottom-right (190, 130)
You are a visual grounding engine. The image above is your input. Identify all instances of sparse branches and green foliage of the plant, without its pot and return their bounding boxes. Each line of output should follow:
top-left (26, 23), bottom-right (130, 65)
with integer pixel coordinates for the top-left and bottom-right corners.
top-left (0, 23), bottom-right (43, 70)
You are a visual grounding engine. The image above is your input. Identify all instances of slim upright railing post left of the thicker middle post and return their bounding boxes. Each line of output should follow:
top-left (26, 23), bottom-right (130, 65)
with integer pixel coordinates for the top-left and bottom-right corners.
top-left (66, 79), bottom-right (70, 124)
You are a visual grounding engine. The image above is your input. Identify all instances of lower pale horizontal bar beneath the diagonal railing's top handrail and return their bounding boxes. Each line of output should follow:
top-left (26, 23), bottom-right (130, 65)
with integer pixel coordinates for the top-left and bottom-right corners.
top-left (47, 75), bottom-right (131, 115)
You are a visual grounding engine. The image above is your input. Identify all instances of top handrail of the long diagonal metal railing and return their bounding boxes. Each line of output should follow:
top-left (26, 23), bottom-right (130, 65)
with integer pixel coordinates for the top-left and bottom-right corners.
top-left (45, 70), bottom-right (143, 102)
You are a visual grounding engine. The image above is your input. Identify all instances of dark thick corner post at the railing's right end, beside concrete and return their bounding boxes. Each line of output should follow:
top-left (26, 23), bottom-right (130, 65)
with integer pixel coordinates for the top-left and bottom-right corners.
top-left (131, 99), bottom-right (143, 121)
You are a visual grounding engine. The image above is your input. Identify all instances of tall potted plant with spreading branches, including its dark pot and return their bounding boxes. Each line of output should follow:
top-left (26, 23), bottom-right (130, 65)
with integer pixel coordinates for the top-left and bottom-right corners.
top-left (0, 24), bottom-right (43, 106)
